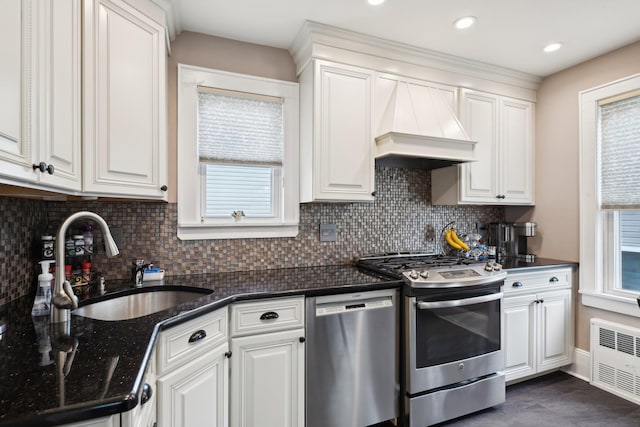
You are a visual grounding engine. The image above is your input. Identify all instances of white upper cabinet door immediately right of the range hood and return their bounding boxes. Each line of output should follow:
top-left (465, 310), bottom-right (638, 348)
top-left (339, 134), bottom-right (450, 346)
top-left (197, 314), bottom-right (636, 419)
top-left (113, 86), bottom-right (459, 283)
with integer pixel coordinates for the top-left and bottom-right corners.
top-left (459, 90), bottom-right (500, 203)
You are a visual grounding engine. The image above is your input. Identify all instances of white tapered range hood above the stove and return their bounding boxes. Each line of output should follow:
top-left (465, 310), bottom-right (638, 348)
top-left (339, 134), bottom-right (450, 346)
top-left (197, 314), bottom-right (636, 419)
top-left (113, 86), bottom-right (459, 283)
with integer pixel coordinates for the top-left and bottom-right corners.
top-left (376, 81), bottom-right (476, 169)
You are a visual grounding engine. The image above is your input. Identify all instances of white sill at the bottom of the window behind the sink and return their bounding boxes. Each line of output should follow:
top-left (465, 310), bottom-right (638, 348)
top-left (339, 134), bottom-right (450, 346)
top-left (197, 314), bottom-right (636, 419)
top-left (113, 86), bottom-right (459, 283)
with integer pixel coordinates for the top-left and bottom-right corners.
top-left (178, 223), bottom-right (298, 240)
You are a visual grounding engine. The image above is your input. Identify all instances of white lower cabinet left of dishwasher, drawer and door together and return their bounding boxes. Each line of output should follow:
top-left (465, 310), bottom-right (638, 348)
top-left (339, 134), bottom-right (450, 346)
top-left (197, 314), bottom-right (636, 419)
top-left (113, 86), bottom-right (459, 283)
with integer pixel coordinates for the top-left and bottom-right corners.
top-left (230, 297), bottom-right (304, 427)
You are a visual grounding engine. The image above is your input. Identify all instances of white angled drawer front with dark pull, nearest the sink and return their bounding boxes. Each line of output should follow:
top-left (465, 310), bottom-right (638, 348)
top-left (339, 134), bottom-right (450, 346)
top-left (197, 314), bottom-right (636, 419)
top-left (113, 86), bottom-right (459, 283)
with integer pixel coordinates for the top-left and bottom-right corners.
top-left (157, 307), bottom-right (228, 375)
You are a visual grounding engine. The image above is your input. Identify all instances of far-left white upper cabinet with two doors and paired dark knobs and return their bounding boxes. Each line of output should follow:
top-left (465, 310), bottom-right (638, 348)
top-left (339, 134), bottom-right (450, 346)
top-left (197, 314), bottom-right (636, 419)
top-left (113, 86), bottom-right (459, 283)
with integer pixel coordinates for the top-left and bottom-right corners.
top-left (0, 0), bottom-right (82, 191)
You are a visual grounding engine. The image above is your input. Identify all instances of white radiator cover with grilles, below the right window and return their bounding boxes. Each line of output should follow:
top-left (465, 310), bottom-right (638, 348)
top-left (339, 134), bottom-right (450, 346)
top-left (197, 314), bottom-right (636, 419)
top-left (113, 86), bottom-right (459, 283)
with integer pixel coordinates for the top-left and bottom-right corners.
top-left (591, 318), bottom-right (640, 404)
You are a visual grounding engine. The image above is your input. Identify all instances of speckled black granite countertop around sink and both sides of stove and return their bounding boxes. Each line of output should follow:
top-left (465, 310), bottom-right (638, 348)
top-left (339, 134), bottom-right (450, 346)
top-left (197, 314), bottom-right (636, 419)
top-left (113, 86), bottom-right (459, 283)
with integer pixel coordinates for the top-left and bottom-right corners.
top-left (0, 258), bottom-right (576, 427)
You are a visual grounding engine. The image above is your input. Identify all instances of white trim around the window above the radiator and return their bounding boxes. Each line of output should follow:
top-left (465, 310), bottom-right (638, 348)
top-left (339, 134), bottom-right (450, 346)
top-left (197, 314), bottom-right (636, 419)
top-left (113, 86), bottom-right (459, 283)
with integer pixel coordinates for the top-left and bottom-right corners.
top-left (579, 74), bottom-right (640, 317)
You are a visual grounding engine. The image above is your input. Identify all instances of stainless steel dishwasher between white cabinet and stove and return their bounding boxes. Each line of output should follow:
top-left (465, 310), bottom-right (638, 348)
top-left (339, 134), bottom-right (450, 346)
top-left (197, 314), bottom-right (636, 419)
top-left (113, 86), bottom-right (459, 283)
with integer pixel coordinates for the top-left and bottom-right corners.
top-left (306, 289), bottom-right (399, 427)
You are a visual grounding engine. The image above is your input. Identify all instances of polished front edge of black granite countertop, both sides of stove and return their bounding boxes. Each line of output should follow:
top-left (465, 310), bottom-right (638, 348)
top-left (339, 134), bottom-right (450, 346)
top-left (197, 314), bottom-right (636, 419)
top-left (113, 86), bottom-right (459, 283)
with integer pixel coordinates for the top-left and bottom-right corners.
top-left (0, 258), bottom-right (578, 427)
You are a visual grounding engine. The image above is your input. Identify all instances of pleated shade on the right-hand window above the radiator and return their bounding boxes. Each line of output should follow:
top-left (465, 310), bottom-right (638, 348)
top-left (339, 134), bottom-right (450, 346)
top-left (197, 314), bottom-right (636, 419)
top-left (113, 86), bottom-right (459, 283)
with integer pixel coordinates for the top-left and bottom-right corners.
top-left (599, 95), bottom-right (640, 209)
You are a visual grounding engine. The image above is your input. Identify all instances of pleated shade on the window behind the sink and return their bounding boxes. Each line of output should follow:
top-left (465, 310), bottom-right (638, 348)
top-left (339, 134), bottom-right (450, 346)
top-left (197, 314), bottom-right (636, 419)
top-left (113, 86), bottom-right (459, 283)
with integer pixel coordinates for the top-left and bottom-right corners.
top-left (198, 87), bottom-right (284, 166)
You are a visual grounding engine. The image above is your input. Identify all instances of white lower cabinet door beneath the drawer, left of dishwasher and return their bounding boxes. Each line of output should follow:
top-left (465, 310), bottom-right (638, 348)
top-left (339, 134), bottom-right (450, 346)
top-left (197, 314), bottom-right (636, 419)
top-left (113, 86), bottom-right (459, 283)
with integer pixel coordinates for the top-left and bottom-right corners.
top-left (231, 329), bottom-right (304, 427)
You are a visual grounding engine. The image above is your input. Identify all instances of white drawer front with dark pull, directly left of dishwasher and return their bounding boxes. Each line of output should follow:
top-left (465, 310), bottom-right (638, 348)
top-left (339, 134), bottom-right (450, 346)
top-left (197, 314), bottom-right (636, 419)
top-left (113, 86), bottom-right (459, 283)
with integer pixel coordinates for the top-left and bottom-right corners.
top-left (231, 297), bottom-right (304, 336)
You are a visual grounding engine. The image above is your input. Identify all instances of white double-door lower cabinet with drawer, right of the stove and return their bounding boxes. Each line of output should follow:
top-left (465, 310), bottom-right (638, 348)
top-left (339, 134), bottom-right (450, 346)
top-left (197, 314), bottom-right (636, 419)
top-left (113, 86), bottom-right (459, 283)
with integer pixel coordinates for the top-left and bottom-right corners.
top-left (503, 268), bottom-right (573, 381)
